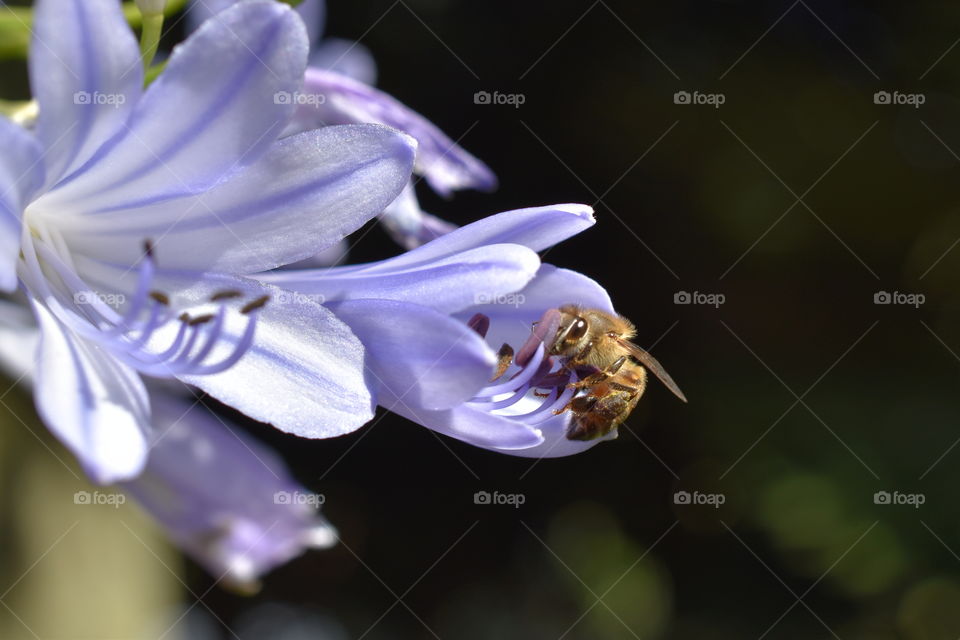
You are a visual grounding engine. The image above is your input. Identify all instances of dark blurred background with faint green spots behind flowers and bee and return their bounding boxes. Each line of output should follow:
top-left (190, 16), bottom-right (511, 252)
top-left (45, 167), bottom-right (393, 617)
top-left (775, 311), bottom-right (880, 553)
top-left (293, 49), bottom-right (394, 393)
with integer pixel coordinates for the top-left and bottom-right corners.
top-left (5, 0), bottom-right (960, 640)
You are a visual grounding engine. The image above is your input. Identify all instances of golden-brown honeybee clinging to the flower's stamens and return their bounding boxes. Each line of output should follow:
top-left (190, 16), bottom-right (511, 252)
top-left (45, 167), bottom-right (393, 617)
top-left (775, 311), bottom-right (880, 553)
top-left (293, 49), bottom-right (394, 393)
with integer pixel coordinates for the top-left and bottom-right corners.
top-left (549, 304), bottom-right (687, 440)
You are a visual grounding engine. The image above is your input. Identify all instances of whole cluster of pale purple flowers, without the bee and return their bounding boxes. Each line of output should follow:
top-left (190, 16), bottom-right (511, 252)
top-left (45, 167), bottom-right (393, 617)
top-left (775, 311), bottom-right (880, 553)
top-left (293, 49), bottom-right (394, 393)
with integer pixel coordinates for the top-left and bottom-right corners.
top-left (0, 0), bottom-right (624, 585)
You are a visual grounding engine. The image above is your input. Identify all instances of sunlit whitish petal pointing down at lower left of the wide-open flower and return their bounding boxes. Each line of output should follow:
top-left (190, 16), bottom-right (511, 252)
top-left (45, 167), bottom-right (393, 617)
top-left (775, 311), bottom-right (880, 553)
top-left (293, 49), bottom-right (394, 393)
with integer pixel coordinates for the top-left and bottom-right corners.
top-left (33, 303), bottom-right (150, 484)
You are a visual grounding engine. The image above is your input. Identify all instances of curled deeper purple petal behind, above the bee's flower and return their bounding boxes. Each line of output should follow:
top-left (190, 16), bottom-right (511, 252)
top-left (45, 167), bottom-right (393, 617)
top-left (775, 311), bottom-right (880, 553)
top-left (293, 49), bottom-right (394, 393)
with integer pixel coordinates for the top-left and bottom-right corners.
top-left (288, 67), bottom-right (497, 195)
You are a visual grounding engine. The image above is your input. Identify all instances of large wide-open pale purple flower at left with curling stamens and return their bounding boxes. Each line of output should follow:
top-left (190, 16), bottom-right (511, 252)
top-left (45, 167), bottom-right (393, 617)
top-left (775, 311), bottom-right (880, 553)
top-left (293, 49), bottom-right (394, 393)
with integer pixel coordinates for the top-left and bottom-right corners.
top-left (6, 0), bottom-right (415, 483)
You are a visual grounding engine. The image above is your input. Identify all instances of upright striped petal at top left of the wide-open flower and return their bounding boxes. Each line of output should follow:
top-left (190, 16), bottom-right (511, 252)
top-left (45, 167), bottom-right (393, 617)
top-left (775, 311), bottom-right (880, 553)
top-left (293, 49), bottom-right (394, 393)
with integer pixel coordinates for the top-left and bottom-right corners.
top-left (29, 0), bottom-right (143, 184)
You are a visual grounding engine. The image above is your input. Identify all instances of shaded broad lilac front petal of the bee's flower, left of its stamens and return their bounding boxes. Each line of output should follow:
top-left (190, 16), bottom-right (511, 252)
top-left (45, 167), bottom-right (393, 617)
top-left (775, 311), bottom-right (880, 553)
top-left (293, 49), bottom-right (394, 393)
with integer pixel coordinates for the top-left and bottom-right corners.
top-left (328, 300), bottom-right (496, 409)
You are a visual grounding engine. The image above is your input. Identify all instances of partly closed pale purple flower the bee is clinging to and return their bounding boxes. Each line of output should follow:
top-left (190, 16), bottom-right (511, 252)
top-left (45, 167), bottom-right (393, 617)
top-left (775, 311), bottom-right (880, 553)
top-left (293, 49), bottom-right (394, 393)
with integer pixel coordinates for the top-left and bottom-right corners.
top-left (261, 205), bottom-right (616, 457)
